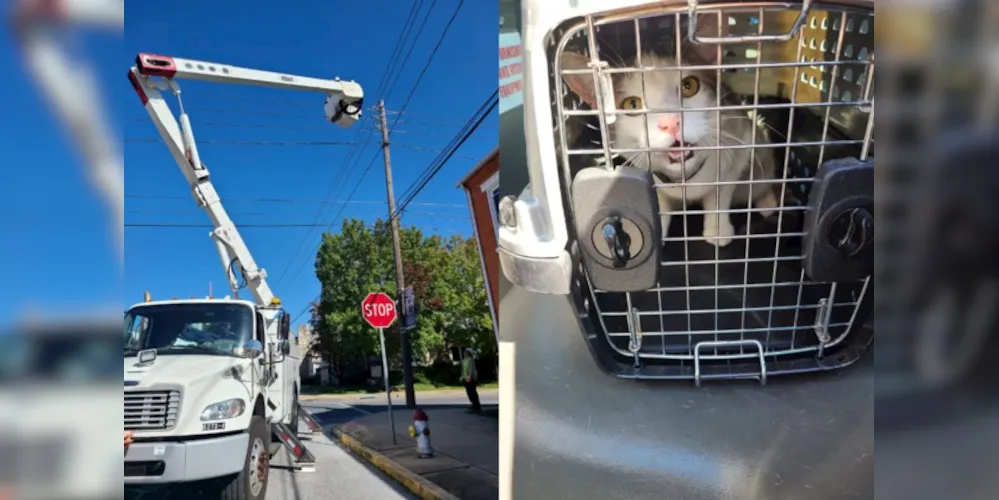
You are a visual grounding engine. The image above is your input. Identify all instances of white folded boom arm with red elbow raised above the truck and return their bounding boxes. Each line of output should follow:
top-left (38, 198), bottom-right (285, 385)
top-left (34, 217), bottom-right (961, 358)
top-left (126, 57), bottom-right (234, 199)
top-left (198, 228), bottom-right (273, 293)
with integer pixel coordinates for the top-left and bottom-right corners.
top-left (128, 54), bottom-right (364, 306)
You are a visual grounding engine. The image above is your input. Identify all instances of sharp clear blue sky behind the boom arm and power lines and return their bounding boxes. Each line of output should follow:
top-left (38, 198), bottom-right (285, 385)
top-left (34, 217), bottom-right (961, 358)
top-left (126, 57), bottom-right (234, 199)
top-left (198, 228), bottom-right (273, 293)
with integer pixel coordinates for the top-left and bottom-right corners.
top-left (125, 0), bottom-right (498, 328)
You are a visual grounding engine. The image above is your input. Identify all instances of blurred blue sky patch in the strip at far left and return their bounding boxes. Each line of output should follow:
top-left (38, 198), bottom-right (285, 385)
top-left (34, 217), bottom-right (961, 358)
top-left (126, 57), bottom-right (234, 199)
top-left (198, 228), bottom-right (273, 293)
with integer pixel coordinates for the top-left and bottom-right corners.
top-left (0, 22), bottom-right (123, 320)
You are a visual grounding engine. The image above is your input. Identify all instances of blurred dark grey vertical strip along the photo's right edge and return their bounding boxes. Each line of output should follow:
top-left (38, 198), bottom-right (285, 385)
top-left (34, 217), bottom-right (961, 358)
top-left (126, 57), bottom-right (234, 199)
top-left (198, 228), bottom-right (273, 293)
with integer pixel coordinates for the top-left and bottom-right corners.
top-left (874, 0), bottom-right (999, 499)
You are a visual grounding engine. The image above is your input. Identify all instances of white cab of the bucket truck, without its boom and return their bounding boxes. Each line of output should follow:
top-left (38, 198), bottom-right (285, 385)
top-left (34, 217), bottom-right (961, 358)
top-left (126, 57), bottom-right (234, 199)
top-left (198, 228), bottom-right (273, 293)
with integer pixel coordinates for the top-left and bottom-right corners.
top-left (124, 299), bottom-right (299, 498)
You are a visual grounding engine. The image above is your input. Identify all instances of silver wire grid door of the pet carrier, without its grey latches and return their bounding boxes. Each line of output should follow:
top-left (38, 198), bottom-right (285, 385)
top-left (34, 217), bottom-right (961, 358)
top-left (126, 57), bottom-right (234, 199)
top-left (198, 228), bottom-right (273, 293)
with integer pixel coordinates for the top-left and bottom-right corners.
top-left (550, 3), bottom-right (874, 377)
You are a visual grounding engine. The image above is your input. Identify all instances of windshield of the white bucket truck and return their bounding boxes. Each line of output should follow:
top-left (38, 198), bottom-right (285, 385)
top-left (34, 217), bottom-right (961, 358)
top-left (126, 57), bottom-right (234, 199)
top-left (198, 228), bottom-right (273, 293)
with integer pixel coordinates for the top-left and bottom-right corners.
top-left (124, 303), bottom-right (253, 357)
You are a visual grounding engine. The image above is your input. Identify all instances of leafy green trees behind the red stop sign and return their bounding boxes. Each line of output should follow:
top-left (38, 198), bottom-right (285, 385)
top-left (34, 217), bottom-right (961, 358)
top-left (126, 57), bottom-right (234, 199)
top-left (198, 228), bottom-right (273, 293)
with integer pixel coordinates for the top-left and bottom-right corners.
top-left (312, 219), bottom-right (496, 384)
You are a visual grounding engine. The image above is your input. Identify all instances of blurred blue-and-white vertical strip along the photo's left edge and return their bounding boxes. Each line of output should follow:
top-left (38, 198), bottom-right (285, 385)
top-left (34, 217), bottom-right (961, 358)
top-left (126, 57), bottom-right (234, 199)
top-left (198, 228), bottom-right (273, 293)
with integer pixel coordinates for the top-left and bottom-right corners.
top-left (0, 0), bottom-right (123, 498)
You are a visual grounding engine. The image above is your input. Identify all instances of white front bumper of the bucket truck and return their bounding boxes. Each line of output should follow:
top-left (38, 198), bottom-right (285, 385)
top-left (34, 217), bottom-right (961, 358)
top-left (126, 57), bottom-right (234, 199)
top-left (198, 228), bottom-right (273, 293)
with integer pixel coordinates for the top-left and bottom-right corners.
top-left (125, 432), bottom-right (250, 484)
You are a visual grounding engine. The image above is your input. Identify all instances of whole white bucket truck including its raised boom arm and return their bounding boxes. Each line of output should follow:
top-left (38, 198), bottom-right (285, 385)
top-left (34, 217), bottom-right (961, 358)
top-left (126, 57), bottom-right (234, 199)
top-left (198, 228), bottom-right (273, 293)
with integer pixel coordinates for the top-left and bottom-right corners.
top-left (124, 54), bottom-right (363, 500)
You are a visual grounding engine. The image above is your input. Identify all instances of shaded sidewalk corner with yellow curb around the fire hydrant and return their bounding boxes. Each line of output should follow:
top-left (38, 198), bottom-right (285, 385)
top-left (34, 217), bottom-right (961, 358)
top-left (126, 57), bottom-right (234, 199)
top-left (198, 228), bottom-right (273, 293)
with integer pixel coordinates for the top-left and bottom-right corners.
top-left (334, 405), bottom-right (499, 500)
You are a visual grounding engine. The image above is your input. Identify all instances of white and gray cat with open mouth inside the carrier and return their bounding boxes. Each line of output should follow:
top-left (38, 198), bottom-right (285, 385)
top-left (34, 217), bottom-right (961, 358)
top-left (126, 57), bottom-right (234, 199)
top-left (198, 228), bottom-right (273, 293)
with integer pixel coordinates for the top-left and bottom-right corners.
top-left (562, 42), bottom-right (778, 247)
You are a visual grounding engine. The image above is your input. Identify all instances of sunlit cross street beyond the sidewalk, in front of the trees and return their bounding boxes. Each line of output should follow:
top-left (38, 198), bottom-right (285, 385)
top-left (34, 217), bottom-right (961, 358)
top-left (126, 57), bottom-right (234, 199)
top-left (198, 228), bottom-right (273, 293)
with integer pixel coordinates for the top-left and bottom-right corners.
top-left (302, 389), bottom-right (499, 431)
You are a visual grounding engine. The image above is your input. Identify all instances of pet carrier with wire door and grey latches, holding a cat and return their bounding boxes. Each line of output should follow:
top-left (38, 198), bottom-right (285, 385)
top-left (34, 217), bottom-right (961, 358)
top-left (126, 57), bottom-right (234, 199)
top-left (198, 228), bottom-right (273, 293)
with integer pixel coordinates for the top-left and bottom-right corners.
top-left (500, 0), bottom-right (874, 384)
